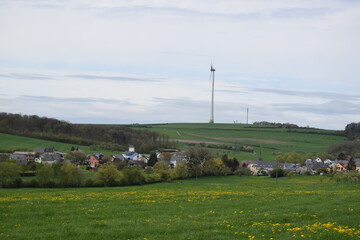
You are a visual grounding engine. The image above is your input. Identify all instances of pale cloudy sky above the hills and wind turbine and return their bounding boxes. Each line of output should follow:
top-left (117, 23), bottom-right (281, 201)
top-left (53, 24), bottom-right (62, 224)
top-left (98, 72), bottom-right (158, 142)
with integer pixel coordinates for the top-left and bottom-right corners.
top-left (0, 0), bottom-right (360, 130)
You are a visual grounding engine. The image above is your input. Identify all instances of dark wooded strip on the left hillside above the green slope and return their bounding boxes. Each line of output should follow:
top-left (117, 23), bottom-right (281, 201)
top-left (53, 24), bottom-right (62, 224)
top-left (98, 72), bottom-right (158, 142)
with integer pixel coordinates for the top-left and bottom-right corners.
top-left (0, 113), bottom-right (173, 152)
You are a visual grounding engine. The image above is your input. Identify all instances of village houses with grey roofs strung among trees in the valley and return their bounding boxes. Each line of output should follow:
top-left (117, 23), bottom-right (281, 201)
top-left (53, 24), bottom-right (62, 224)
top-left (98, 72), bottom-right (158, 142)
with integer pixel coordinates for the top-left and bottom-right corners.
top-left (2, 145), bottom-right (360, 176)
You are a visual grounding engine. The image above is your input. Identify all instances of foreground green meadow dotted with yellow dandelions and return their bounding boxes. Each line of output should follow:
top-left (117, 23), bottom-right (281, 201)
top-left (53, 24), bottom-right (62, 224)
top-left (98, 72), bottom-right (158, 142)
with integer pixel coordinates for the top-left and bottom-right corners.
top-left (0, 176), bottom-right (360, 240)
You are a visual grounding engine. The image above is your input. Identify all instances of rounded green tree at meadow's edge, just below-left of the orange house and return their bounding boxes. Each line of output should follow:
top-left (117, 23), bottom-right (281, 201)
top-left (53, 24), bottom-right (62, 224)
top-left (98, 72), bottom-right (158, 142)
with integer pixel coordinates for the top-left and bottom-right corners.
top-left (59, 162), bottom-right (83, 187)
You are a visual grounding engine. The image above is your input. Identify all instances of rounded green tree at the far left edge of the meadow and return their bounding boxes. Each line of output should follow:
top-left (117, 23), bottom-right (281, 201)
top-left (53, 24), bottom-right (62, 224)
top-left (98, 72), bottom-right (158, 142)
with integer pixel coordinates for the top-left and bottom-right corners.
top-left (0, 161), bottom-right (20, 187)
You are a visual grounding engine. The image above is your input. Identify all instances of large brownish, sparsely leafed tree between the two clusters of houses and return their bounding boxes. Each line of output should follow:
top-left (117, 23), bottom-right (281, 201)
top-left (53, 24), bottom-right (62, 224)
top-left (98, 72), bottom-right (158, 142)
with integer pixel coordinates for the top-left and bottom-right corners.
top-left (186, 145), bottom-right (212, 178)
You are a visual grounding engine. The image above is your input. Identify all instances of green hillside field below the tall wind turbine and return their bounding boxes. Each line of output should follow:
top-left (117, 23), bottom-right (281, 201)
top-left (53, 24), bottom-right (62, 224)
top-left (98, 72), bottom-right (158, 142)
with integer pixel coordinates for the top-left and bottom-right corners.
top-left (130, 123), bottom-right (346, 161)
